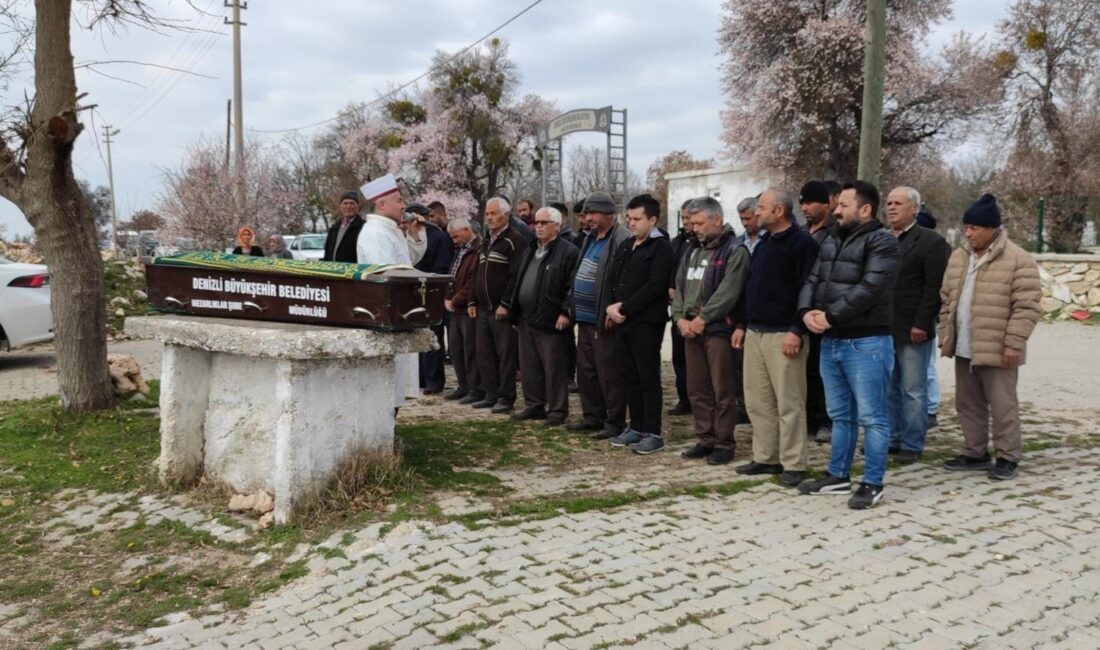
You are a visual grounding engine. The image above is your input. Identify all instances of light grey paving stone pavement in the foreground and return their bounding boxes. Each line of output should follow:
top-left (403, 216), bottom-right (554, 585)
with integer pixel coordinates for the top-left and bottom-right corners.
top-left (113, 448), bottom-right (1100, 650)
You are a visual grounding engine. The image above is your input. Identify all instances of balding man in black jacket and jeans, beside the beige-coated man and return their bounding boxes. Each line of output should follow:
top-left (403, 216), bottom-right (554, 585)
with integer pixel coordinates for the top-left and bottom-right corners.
top-left (887, 187), bottom-right (952, 465)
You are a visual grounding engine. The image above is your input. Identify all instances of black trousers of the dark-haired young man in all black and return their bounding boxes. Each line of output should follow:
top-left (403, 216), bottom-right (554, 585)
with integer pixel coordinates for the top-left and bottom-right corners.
top-left (615, 322), bottom-right (664, 436)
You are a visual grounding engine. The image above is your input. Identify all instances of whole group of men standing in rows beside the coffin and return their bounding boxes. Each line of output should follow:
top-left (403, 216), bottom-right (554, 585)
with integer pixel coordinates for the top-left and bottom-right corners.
top-left (326, 175), bottom-right (1041, 509)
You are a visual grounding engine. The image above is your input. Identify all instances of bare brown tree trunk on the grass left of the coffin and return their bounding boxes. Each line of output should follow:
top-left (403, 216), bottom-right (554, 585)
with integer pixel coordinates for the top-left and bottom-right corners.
top-left (15, 0), bottom-right (114, 412)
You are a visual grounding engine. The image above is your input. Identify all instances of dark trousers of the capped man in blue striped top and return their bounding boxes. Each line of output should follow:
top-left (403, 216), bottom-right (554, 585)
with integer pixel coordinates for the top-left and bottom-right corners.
top-left (576, 322), bottom-right (626, 427)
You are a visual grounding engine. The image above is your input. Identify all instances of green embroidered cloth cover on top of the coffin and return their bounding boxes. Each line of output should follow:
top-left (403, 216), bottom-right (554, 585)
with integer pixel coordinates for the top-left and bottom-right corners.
top-left (153, 252), bottom-right (413, 280)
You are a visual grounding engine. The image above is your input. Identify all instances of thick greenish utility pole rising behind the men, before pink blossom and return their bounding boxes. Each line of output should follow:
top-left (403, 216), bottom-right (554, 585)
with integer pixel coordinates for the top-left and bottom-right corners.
top-left (857, 0), bottom-right (887, 185)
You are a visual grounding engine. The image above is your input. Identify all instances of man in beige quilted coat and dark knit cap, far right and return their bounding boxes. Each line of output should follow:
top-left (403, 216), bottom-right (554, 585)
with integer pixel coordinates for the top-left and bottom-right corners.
top-left (939, 194), bottom-right (1042, 481)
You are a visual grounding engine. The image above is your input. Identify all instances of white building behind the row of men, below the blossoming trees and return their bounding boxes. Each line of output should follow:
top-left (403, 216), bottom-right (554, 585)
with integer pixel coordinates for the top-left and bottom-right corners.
top-left (664, 167), bottom-right (772, 235)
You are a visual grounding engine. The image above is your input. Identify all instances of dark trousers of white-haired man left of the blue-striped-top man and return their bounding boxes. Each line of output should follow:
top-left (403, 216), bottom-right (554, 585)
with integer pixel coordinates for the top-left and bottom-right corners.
top-left (519, 320), bottom-right (569, 418)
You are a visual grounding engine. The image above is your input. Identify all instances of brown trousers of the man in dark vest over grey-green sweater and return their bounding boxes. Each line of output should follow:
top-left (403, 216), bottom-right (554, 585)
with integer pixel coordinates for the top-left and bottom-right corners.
top-left (684, 334), bottom-right (737, 450)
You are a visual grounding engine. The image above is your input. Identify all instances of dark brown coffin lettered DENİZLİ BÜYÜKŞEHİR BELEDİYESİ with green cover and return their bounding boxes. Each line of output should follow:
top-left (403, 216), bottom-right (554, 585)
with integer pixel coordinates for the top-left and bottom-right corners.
top-left (145, 253), bottom-right (452, 330)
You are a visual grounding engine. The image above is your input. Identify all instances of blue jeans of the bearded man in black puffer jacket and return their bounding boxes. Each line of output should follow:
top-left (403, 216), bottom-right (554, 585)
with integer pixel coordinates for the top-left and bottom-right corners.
top-left (821, 337), bottom-right (894, 485)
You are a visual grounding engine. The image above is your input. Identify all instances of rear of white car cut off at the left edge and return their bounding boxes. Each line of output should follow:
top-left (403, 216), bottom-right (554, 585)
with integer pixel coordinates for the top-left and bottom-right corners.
top-left (0, 257), bottom-right (54, 348)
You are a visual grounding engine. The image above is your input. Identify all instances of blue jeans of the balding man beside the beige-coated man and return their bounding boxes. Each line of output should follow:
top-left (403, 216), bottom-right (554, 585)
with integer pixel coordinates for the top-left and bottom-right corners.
top-left (889, 341), bottom-right (934, 452)
